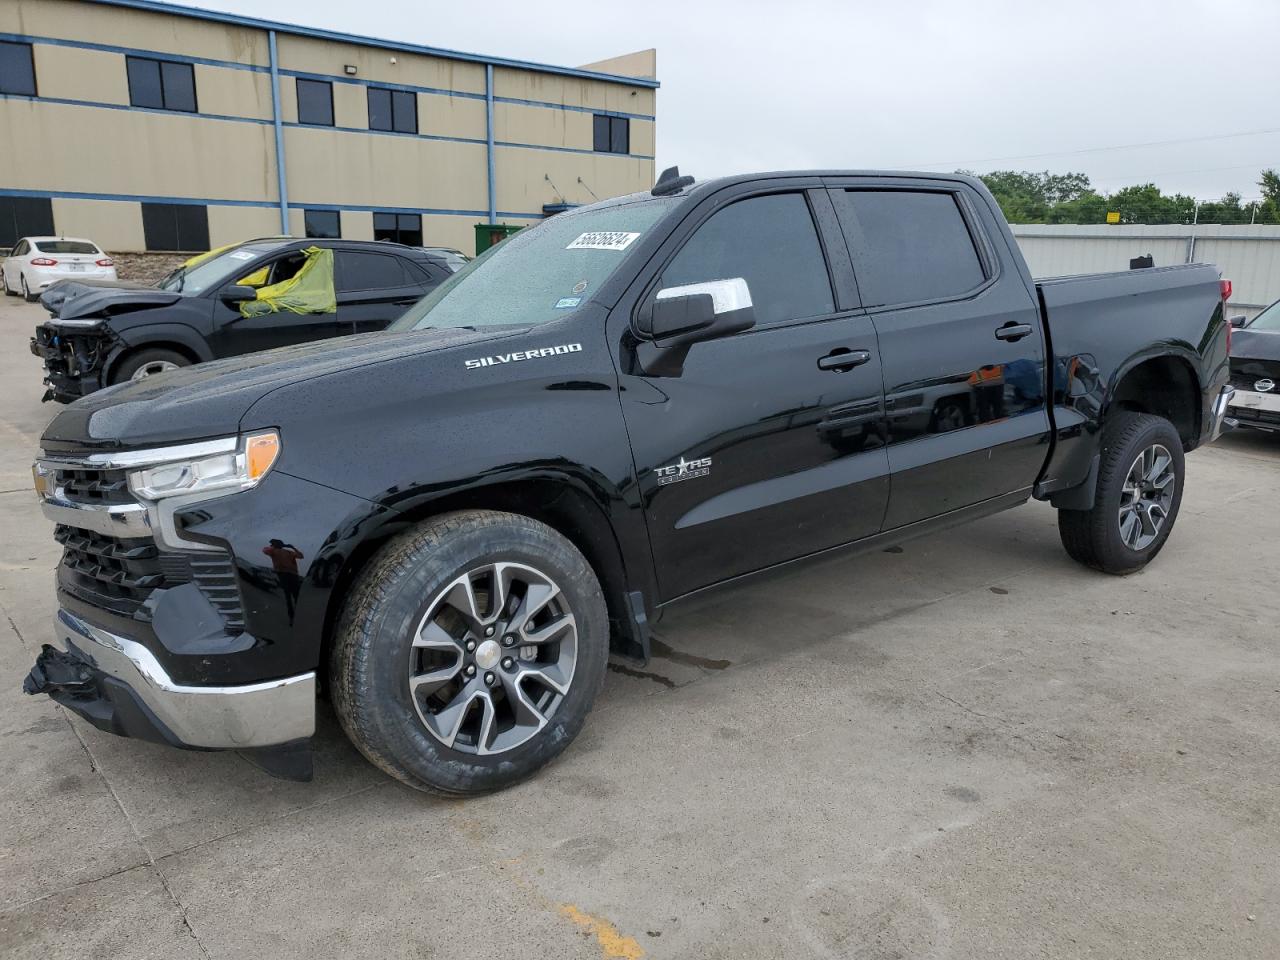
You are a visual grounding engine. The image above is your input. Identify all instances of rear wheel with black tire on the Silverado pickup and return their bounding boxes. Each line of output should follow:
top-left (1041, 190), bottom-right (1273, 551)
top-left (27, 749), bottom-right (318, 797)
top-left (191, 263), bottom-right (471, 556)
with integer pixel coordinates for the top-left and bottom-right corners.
top-left (1057, 411), bottom-right (1185, 575)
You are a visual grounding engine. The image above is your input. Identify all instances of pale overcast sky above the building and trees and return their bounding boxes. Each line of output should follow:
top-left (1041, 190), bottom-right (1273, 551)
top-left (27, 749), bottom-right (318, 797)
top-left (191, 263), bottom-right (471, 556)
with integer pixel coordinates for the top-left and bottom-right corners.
top-left (172, 0), bottom-right (1280, 200)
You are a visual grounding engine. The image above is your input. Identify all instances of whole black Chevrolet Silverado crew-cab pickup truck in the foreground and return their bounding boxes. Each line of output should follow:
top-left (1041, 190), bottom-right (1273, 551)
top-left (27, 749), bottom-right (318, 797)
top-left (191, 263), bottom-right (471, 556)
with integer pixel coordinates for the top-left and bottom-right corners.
top-left (27, 170), bottom-right (1231, 795)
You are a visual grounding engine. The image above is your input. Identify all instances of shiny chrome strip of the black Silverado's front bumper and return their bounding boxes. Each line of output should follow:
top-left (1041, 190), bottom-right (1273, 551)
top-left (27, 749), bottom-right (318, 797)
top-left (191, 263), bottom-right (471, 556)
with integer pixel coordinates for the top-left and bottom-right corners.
top-left (54, 609), bottom-right (316, 750)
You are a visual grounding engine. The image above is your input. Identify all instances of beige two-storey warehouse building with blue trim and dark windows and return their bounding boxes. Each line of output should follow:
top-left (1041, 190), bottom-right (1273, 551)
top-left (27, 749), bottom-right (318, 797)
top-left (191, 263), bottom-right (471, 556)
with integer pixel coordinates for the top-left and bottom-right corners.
top-left (0, 0), bottom-right (658, 252)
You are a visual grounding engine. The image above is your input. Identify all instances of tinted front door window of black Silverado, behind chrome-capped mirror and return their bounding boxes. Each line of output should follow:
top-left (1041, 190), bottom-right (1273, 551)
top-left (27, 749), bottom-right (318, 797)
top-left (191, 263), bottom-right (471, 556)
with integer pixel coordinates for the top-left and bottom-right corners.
top-left (662, 193), bottom-right (835, 324)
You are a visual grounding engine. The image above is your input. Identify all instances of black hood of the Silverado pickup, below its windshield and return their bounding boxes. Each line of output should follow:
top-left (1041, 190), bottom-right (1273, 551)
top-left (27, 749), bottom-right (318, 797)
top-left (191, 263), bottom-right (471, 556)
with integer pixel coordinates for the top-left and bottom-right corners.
top-left (41, 328), bottom-right (512, 452)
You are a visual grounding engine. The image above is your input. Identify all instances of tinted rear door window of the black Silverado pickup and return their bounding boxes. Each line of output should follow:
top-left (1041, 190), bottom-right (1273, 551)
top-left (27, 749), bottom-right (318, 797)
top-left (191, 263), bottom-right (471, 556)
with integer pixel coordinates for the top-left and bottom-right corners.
top-left (836, 191), bottom-right (986, 307)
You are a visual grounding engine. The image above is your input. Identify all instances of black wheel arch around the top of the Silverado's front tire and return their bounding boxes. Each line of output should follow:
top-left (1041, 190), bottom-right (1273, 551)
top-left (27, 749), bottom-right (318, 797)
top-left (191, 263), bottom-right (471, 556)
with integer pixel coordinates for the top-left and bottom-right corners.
top-left (319, 475), bottom-right (649, 686)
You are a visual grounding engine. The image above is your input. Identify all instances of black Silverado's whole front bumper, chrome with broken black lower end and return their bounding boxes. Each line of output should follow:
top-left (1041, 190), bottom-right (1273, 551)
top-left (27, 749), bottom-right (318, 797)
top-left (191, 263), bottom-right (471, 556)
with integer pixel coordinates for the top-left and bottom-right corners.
top-left (23, 609), bottom-right (316, 750)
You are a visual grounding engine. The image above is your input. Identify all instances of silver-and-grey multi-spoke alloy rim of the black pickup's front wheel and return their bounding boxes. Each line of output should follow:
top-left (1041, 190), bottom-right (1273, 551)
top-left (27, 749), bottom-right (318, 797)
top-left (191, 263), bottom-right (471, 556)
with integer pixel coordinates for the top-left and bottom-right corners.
top-left (408, 562), bottom-right (577, 755)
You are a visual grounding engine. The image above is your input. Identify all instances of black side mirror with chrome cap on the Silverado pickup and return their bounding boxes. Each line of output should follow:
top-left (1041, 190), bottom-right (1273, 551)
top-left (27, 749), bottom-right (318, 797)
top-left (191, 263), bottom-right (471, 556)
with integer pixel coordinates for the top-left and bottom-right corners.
top-left (636, 276), bottom-right (755, 376)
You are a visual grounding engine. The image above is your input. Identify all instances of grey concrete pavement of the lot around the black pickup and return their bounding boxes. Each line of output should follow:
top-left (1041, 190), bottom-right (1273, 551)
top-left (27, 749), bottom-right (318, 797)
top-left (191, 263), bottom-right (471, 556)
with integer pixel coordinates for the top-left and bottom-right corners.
top-left (0, 300), bottom-right (1280, 960)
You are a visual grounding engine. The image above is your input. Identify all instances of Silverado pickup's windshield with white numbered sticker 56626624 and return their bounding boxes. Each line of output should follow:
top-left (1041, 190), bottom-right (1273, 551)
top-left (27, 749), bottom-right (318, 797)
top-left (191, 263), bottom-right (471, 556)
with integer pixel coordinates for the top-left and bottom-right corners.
top-left (387, 197), bottom-right (680, 330)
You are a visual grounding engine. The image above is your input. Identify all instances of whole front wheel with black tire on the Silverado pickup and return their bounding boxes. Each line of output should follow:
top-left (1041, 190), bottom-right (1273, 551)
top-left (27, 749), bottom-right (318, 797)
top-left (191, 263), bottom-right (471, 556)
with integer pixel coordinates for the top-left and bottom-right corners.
top-left (330, 511), bottom-right (609, 796)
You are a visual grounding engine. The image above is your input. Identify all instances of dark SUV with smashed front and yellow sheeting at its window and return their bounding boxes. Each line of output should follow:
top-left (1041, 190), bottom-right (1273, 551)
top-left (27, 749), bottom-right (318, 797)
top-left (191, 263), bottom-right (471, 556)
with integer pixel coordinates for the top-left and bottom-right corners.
top-left (31, 237), bottom-right (457, 403)
